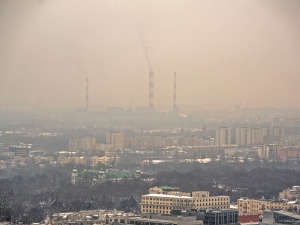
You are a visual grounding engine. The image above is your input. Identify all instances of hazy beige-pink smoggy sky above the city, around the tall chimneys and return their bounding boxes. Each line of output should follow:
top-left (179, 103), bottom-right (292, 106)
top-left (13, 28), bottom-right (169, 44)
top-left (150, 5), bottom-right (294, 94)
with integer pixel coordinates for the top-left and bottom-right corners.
top-left (0, 0), bottom-right (300, 110)
